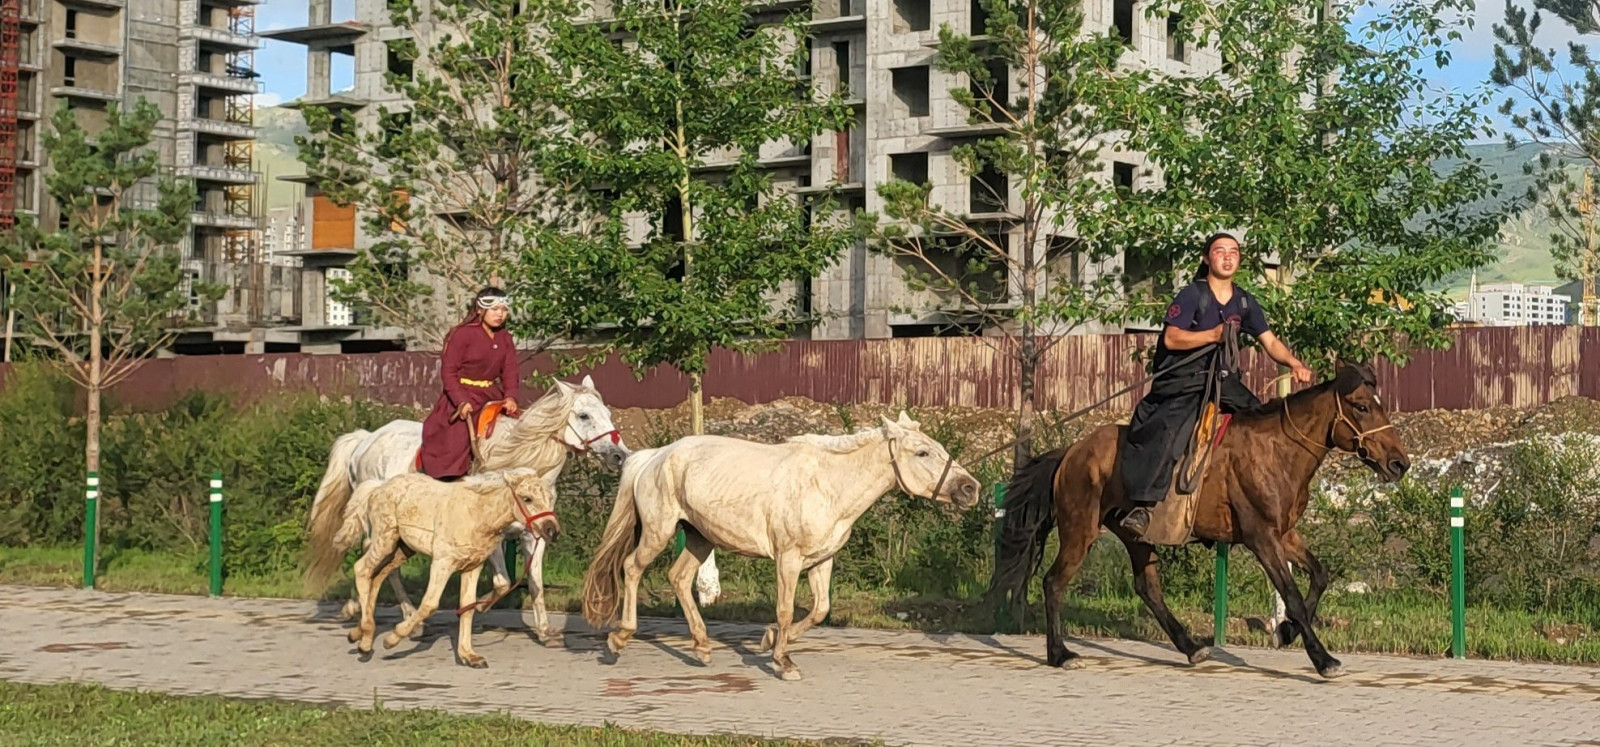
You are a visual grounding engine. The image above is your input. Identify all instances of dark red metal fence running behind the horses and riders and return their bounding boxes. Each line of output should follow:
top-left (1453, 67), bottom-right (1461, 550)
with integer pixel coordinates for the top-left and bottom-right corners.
top-left (0, 326), bottom-right (1600, 411)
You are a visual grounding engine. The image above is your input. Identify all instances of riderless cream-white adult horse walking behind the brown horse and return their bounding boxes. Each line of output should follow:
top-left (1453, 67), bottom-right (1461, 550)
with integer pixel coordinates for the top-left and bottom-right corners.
top-left (584, 413), bottom-right (978, 680)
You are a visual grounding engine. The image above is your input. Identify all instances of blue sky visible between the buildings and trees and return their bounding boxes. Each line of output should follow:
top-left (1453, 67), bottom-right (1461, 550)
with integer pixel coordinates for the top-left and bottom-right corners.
top-left (256, 0), bottom-right (1571, 140)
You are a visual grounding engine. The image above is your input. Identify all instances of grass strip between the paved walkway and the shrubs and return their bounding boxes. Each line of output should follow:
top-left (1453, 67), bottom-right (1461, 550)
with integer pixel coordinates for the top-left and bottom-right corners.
top-left (0, 547), bottom-right (1600, 664)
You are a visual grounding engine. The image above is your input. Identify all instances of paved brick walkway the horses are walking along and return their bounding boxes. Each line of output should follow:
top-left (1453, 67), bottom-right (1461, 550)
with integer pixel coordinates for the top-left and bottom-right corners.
top-left (0, 587), bottom-right (1600, 747)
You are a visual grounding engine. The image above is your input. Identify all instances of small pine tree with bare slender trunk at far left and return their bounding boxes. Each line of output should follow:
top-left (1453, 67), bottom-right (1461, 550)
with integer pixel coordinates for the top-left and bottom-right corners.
top-left (0, 99), bottom-right (212, 566)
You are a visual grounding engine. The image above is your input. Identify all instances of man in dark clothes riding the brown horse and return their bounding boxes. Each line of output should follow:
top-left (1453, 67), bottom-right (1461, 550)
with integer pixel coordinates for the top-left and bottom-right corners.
top-left (1120, 234), bottom-right (1312, 536)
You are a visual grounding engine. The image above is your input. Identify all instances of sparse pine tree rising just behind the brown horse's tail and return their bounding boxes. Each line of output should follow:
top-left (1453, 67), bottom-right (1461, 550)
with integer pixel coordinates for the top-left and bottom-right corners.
top-left (861, 0), bottom-right (1139, 465)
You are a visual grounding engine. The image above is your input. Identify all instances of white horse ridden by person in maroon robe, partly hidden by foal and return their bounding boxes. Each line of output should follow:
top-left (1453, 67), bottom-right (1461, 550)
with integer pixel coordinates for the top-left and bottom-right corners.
top-left (306, 376), bottom-right (629, 645)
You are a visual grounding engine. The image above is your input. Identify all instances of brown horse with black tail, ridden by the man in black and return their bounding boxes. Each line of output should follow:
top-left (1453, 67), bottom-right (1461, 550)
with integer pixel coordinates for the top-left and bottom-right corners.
top-left (992, 365), bottom-right (1410, 678)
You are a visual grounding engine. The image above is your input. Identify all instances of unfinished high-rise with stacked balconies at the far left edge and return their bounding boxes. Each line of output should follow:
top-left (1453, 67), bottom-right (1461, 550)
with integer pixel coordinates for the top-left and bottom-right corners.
top-left (0, 0), bottom-right (298, 358)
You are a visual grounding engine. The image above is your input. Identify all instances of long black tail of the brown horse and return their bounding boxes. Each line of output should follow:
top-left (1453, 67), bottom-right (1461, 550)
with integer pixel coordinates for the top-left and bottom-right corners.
top-left (989, 448), bottom-right (1067, 605)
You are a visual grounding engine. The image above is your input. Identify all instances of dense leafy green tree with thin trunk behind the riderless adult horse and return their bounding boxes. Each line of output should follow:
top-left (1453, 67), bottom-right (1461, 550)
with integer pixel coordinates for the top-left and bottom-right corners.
top-left (537, 0), bottom-right (851, 432)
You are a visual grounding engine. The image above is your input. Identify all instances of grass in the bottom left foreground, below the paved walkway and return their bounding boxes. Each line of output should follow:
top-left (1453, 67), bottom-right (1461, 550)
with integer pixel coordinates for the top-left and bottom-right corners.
top-left (0, 681), bottom-right (867, 747)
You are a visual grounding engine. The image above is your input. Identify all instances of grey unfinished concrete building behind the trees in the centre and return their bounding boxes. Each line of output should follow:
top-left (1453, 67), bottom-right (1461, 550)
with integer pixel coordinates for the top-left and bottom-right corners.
top-left (266, 0), bottom-right (1254, 348)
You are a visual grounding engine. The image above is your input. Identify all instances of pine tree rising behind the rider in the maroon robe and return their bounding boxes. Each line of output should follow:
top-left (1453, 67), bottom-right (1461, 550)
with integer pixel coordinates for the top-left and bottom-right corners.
top-left (296, 0), bottom-right (603, 349)
